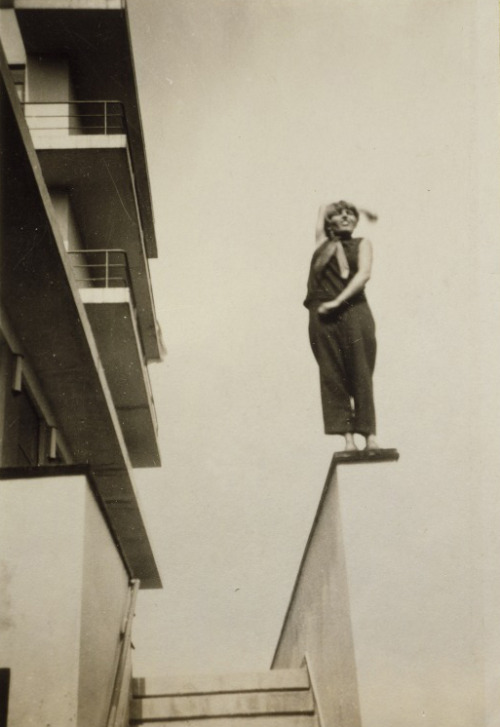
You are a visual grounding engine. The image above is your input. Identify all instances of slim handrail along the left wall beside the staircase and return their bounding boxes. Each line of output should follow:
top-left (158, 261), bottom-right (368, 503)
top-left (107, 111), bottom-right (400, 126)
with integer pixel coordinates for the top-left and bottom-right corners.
top-left (106, 579), bottom-right (140, 727)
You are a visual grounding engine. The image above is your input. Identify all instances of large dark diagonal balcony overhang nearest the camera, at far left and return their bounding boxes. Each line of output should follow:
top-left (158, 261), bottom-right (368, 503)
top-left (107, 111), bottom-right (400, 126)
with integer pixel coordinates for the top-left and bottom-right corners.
top-left (0, 61), bottom-right (161, 588)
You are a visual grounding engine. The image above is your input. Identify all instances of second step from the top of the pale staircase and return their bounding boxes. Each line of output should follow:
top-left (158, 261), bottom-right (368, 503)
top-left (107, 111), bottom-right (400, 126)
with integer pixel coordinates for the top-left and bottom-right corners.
top-left (130, 690), bottom-right (314, 722)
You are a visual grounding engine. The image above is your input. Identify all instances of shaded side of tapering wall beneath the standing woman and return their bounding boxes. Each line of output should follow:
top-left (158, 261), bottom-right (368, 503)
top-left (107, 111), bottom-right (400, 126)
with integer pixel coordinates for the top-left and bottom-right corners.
top-left (273, 460), bottom-right (361, 727)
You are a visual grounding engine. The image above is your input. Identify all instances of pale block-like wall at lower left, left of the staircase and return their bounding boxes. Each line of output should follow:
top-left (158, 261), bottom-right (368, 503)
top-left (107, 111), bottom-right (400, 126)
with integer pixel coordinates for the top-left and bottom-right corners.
top-left (0, 476), bottom-right (128, 727)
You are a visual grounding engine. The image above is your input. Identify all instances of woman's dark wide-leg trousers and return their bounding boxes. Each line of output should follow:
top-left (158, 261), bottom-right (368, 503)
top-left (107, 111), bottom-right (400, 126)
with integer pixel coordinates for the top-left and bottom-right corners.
top-left (309, 302), bottom-right (377, 436)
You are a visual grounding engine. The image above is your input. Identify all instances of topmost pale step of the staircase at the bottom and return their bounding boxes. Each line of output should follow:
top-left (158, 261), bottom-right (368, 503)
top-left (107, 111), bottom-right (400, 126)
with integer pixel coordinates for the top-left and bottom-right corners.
top-left (132, 669), bottom-right (309, 697)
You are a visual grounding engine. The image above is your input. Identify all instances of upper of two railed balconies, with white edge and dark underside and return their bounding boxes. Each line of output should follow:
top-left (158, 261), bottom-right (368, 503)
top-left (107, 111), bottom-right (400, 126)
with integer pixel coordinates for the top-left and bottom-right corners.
top-left (24, 100), bottom-right (160, 361)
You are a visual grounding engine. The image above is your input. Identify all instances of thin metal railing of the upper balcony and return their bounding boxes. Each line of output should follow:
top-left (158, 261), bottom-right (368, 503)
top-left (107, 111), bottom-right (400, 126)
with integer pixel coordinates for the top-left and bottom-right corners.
top-left (23, 100), bottom-right (127, 135)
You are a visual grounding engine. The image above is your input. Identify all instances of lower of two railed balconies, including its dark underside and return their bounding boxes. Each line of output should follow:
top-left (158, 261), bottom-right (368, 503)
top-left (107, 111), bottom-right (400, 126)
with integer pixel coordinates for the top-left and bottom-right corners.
top-left (68, 249), bottom-right (160, 467)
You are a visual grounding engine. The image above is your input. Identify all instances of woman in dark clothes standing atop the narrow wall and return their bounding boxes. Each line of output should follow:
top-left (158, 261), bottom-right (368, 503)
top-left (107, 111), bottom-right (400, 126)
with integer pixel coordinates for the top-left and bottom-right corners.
top-left (304, 200), bottom-right (379, 451)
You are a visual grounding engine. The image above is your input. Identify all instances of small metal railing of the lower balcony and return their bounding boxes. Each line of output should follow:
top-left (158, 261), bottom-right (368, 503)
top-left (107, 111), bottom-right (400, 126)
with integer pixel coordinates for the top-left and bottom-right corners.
top-left (68, 249), bottom-right (132, 293)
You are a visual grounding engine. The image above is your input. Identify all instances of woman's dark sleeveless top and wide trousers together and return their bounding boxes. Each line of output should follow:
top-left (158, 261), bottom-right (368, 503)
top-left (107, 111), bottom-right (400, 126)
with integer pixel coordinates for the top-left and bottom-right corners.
top-left (304, 238), bottom-right (377, 436)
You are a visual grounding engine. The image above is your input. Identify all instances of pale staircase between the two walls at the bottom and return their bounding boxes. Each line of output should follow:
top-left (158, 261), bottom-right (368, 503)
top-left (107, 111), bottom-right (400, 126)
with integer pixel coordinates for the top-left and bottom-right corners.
top-left (130, 668), bottom-right (318, 727)
